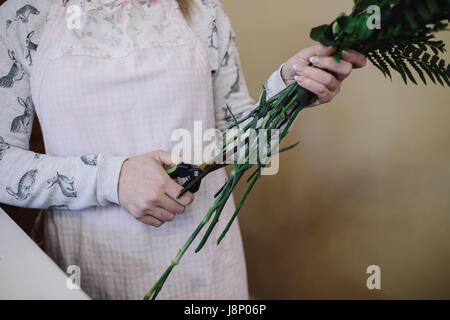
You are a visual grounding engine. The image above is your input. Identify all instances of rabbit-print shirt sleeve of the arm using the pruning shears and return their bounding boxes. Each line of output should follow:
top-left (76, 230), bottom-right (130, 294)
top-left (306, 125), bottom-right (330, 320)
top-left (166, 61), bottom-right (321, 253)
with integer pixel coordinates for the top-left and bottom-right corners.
top-left (0, 0), bottom-right (126, 210)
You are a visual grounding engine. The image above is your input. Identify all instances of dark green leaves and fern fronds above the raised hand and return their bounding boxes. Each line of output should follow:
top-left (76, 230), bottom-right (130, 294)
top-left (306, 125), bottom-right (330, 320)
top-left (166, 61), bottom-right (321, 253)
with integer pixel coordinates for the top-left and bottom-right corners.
top-left (311, 0), bottom-right (450, 86)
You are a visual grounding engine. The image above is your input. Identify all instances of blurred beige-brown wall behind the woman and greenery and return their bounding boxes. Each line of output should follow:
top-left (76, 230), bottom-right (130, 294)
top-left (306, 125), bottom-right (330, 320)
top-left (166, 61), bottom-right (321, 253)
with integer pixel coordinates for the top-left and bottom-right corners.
top-left (222, 0), bottom-right (450, 299)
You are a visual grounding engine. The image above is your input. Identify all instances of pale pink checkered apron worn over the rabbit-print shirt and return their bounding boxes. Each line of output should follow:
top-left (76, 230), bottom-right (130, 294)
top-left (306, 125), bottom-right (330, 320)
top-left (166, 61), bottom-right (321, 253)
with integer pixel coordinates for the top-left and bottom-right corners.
top-left (31, 0), bottom-right (248, 299)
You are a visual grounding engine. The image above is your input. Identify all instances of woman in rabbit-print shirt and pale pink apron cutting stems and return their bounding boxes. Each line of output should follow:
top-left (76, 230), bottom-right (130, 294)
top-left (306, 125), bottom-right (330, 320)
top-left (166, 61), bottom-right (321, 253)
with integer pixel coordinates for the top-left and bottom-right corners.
top-left (0, 0), bottom-right (366, 299)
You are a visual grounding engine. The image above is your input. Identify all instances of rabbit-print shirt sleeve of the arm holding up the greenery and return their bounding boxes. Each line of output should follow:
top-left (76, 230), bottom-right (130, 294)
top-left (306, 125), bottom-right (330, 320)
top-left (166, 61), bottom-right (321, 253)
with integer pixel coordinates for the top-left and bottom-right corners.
top-left (197, 0), bottom-right (286, 129)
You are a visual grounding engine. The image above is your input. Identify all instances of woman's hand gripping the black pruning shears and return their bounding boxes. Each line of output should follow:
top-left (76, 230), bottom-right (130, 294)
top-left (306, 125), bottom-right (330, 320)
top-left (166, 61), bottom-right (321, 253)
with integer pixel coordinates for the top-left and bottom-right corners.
top-left (118, 150), bottom-right (194, 227)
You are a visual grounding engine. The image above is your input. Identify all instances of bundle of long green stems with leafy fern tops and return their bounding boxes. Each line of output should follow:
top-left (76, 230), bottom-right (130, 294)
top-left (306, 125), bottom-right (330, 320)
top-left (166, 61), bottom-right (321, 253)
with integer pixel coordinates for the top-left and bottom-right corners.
top-left (144, 0), bottom-right (450, 300)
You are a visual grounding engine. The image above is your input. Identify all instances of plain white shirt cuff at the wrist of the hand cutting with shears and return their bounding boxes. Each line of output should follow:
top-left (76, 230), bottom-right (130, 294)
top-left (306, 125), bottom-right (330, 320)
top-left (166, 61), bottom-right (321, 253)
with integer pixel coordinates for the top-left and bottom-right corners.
top-left (97, 155), bottom-right (128, 206)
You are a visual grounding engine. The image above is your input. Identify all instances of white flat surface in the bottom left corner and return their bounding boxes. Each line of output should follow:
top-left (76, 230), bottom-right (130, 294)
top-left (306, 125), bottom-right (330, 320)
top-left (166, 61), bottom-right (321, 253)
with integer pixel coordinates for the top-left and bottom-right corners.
top-left (0, 209), bottom-right (89, 300)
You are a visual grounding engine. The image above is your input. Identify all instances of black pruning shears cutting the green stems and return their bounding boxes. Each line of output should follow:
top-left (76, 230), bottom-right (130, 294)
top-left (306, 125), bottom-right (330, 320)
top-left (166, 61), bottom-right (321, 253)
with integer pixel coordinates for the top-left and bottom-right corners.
top-left (166, 162), bottom-right (227, 198)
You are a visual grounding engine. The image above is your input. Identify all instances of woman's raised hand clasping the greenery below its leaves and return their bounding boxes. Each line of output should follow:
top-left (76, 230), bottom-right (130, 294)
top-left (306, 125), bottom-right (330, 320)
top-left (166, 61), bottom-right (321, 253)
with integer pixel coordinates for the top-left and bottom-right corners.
top-left (281, 45), bottom-right (367, 106)
